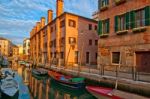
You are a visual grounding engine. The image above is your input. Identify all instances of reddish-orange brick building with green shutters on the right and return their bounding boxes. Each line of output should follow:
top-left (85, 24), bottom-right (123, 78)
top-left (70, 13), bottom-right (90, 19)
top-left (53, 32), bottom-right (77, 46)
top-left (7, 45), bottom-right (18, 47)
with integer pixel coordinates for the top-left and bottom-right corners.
top-left (98, 0), bottom-right (150, 73)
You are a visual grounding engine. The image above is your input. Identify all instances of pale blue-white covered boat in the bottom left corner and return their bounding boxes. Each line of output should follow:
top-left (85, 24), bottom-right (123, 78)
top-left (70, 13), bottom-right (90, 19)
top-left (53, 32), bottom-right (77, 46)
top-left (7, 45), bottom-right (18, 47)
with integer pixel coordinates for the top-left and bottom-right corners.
top-left (0, 76), bottom-right (19, 99)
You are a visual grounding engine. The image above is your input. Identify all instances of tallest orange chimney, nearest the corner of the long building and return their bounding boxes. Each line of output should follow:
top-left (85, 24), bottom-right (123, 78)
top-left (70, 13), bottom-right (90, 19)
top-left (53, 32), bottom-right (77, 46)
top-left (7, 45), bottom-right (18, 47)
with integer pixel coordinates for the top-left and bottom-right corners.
top-left (56, 0), bottom-right (64, 17)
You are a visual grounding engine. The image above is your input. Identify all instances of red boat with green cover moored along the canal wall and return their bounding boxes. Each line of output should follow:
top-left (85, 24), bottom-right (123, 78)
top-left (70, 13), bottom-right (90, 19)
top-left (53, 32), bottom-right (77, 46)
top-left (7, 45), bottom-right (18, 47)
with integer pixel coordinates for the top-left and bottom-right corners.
top-left (48, 71), bottom-right (85, 89)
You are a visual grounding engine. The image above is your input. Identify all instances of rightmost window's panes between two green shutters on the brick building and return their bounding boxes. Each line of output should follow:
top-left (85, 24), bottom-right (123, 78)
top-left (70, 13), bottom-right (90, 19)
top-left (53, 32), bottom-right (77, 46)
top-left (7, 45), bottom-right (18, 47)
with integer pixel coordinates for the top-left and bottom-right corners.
top-left (135, 9), bottom-right (145, 27)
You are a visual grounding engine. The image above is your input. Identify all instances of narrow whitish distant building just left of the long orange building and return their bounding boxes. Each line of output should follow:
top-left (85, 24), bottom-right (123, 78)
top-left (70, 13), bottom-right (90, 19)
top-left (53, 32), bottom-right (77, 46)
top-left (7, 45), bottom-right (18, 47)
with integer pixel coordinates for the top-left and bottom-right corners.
top-left (23, 38), bottom-right (30, 55)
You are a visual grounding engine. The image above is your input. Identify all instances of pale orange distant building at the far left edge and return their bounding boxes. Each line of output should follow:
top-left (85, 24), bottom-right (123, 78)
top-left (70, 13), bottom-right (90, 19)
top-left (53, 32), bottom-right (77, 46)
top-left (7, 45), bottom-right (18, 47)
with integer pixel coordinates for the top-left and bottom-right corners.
top-left (0, 37), bottom-right (12, 56)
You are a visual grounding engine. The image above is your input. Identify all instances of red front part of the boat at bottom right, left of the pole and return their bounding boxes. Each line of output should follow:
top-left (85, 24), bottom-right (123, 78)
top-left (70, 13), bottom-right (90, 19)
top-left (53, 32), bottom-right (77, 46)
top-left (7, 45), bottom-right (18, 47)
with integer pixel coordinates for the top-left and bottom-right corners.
top-left (86, 86), bottom-right (122, 99)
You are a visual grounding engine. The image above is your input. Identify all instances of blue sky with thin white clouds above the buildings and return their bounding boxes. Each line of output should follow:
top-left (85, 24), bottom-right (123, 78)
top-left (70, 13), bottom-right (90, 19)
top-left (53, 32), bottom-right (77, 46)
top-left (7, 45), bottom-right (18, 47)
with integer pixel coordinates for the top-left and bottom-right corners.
top-left (0, 0), bottom-right (98, 44)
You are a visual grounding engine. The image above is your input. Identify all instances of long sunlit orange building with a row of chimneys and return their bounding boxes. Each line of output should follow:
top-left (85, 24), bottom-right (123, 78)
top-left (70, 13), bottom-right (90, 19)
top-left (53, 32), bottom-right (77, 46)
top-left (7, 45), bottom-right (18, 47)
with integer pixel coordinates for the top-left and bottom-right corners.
top-left (30, 0), bottom-right (98, 66)
